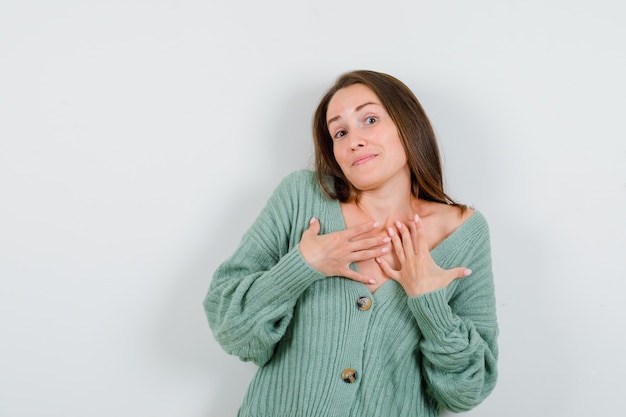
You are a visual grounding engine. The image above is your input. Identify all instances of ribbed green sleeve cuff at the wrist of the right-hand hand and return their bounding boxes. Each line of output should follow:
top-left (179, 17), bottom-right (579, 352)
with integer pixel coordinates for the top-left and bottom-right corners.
top-left (408, 288), bottom-right (459, 341)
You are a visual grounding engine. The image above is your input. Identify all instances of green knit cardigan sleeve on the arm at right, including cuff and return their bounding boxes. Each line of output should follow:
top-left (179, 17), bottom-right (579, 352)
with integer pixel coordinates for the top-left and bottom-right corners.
top-left (409, 219), bottom-right (498, 412)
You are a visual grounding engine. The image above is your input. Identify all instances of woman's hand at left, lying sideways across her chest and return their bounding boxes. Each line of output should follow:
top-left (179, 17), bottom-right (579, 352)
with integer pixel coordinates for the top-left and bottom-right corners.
top-left (300, 217), bottom-right (391, 284)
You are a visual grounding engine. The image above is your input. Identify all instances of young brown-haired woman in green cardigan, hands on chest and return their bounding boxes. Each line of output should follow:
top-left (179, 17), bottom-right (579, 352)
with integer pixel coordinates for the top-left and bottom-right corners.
top-left (204, 71), bottom-right (498, 417)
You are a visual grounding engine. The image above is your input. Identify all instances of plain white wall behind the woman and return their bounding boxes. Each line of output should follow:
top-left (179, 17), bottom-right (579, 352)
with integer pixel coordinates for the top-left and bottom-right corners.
top-left (0, 0), bottom-right (626, 417)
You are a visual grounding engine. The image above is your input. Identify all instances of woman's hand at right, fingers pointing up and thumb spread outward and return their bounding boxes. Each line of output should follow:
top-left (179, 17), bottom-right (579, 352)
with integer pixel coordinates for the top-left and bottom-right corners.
top-left (376, 215), bottom-right (472, 297)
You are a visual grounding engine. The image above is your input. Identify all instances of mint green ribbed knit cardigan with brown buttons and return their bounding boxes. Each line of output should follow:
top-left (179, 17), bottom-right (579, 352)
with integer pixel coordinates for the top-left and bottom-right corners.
top-left (203, 171), bottom-right (498, 417)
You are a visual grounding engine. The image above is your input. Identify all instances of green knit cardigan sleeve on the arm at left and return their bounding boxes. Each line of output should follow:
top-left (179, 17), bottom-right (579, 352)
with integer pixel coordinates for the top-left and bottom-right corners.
top-left (203, 177), bottom-right (324, 366)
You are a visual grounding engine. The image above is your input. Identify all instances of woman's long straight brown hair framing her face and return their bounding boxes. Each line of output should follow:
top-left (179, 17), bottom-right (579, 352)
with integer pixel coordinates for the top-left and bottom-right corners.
top-left (313, 70), bottom-right (458, 205)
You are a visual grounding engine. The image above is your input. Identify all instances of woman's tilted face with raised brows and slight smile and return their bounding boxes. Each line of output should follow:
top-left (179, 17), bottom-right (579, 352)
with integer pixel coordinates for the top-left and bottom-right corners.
top-left (326, 84), bottom-right (410, 191)
